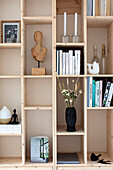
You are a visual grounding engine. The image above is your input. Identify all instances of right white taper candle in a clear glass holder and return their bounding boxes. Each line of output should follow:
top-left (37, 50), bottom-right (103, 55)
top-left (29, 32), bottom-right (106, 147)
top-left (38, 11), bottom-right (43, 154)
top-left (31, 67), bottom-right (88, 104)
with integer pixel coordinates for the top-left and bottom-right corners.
top-left (71, 13), bottom-right (80, 43)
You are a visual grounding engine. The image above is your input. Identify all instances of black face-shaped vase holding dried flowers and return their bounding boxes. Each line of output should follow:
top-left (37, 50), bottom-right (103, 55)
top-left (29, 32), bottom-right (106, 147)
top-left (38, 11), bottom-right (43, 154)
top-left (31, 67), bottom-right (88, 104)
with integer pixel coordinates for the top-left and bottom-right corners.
top-left (66, 107), bottom-right (76, 132)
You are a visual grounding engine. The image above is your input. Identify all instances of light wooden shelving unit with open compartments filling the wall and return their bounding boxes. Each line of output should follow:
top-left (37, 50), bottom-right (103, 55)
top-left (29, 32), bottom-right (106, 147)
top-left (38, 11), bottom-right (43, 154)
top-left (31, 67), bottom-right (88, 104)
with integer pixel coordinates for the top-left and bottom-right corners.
top-left (0, 0), bottom-right (113, 170)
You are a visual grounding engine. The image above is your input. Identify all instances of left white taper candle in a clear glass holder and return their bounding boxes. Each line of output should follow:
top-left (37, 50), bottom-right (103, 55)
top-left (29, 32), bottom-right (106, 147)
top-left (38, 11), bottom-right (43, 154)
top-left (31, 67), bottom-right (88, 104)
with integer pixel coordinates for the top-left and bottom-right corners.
top-left (61, 12), bottom-right (69, 43)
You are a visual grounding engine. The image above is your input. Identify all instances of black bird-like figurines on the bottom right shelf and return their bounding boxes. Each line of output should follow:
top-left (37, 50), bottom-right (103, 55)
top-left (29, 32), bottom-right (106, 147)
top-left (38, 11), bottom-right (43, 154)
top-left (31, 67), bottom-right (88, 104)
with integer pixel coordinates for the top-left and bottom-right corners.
top-left (90, 153), bottom-right (111, 164)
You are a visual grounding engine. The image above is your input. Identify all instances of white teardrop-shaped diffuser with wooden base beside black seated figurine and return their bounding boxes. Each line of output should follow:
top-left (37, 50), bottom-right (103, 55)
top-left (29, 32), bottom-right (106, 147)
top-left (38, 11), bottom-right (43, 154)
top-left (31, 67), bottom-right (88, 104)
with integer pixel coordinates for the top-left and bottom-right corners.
top-left (0, 106), bottom-right (12, 124)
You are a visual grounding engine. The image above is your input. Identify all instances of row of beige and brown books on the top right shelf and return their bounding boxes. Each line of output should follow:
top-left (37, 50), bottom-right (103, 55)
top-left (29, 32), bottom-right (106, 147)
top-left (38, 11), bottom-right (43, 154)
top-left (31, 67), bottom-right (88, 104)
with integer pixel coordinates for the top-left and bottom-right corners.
top-left (87, 0), bottom-right (113, 16)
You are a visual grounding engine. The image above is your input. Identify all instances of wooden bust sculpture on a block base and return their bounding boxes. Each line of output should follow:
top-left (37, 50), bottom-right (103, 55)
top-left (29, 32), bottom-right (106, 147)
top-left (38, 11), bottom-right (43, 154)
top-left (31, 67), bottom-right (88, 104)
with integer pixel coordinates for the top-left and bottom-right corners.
top-left (31, 31), bottom-right (47, 75)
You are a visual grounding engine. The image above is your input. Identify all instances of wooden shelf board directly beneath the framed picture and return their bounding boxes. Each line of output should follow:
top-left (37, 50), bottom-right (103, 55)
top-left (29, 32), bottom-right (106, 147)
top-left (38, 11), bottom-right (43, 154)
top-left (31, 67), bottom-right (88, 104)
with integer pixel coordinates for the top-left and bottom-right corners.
top-left (0, 43), bottom-right (21, 48)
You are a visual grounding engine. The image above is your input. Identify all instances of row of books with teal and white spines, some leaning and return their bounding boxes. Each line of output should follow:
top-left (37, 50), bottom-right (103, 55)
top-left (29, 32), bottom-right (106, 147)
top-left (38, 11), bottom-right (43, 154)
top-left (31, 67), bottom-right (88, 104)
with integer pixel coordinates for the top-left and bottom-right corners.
top-left (87, 77), bottom-right (113, 107)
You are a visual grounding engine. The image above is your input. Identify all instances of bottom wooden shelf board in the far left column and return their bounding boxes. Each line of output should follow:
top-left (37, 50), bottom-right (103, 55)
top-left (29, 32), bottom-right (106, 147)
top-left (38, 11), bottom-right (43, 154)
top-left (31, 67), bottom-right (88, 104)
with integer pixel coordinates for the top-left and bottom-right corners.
top-left (0, 157), bottom-right (22, 167)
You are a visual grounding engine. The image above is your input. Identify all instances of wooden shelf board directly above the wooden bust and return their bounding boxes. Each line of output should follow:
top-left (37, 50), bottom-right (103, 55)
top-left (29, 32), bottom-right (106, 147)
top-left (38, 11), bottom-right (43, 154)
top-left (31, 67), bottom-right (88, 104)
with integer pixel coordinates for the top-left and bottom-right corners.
top-left (23, 16), bottom-right (52, 24)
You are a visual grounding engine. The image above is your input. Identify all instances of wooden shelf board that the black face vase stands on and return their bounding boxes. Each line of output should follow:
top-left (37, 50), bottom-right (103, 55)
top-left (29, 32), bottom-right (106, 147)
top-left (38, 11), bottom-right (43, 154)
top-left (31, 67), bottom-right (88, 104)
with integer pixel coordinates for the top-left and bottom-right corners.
top-left (57, 125), bottom-right (85, 136)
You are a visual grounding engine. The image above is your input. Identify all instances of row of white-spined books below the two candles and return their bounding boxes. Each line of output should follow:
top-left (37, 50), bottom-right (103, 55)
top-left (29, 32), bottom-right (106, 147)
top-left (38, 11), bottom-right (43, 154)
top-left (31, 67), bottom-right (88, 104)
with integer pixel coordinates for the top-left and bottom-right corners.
top-left (56, 50), bottom-right (81, 75)
